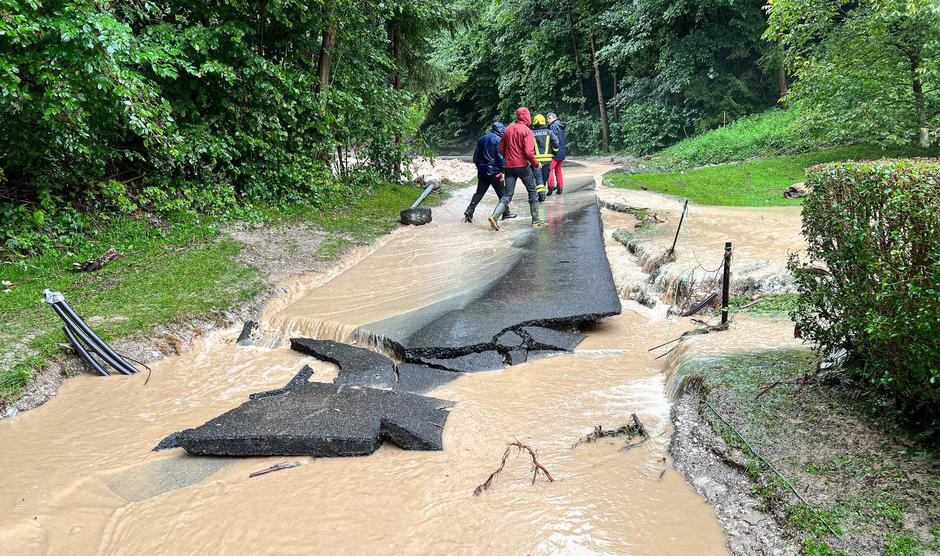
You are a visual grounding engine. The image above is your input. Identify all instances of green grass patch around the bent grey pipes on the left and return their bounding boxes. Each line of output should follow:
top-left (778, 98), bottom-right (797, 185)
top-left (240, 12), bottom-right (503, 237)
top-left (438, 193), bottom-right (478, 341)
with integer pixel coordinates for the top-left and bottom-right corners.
top-left (0, 218), bottom-right (262, 400)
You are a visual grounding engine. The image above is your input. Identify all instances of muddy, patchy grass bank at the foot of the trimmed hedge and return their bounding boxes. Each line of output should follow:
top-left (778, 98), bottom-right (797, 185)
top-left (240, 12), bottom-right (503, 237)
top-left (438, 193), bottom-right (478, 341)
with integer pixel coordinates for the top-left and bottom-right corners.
top-left (694, 350), bottom-right (940, 555)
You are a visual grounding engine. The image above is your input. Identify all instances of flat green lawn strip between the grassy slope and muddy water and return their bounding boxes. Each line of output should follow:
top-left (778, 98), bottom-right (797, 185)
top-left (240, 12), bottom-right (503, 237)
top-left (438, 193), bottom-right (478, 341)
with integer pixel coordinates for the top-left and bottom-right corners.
top-left (607, 145), bottom-right (920, 207)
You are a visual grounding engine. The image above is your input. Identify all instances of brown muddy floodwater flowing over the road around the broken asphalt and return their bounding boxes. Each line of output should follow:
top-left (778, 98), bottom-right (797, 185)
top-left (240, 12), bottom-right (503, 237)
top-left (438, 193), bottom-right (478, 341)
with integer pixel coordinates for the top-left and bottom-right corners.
top-left (0, 166), bottom-right (726, 555)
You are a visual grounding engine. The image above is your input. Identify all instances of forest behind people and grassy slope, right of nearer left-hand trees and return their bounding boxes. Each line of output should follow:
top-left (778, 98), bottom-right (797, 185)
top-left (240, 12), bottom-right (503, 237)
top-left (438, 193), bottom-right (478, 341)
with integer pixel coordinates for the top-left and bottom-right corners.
top-left (428, 0), bottom-right (940, 154)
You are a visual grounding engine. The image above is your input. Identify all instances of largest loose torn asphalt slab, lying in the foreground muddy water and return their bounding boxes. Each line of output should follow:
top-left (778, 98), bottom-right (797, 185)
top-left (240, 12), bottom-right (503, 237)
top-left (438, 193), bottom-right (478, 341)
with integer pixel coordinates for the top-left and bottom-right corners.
top-left (154, 374), bottom-right (453, 457)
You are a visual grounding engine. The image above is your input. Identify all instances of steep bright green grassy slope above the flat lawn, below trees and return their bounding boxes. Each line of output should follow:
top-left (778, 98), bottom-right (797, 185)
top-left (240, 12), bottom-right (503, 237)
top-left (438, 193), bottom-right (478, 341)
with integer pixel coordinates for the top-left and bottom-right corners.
top-left (657, 108), bottom-right (817, 166)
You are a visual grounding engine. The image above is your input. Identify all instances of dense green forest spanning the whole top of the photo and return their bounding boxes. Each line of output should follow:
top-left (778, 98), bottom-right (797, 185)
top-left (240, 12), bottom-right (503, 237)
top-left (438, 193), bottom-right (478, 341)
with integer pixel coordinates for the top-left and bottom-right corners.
top-left (0, 0), bottom-right (940, 253)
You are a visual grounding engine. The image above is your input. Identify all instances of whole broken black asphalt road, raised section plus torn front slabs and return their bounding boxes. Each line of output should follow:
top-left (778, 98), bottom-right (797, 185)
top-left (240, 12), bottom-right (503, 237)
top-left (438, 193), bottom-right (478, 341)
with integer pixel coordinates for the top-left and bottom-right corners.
top-left (157, 179), bottom-right (621, 457)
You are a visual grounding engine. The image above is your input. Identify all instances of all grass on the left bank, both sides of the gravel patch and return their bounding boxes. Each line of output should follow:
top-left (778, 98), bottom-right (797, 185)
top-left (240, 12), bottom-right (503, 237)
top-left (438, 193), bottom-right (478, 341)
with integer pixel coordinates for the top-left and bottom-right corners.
top-left (0, 185), bottom-right (446, 402)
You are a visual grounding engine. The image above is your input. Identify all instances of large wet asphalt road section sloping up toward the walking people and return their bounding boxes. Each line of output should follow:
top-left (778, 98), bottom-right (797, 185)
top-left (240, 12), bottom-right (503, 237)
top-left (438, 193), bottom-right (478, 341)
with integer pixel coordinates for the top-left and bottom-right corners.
top-left (385, 200), bottom-right (621, 364)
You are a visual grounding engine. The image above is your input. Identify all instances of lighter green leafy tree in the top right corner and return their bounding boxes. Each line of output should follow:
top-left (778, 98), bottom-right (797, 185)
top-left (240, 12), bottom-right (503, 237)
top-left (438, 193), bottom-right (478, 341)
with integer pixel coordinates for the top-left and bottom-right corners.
top-left (766, 0), bottom-right (940, 147)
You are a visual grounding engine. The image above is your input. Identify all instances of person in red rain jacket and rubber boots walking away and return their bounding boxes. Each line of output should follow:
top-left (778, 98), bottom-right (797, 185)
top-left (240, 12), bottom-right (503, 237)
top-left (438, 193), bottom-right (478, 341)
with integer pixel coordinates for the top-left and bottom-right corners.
top-left (489, 108), bottom-right (545, 231)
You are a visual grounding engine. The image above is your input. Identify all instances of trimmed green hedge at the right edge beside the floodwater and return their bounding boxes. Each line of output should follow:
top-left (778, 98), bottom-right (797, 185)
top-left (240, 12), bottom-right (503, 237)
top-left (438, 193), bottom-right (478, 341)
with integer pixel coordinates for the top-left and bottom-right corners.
top-left (790, 159), bottom-right (940, 433)
